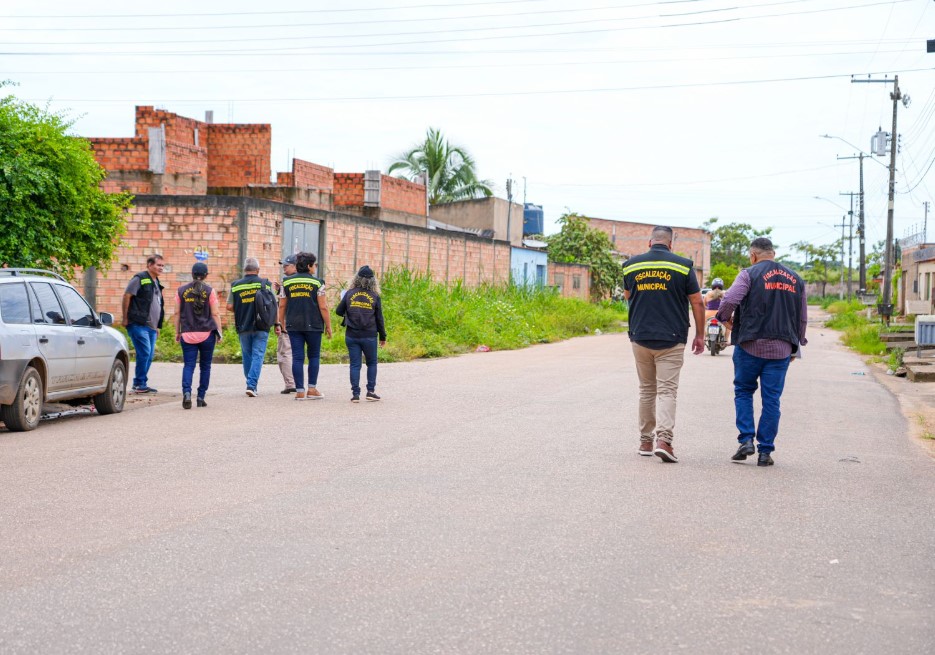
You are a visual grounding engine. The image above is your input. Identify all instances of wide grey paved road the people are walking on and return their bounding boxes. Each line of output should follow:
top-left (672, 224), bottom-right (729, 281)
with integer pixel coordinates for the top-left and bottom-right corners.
top-left (0, 328), bottom-right (935, 655)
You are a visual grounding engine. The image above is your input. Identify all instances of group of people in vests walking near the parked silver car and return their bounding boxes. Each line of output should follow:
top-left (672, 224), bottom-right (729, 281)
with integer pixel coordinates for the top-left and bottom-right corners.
top-left (123, 252), bottom-right (386, 409)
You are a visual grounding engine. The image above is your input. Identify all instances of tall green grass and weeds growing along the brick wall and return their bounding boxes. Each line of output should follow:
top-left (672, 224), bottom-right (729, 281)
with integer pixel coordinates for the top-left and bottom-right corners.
top-left (144, 270), bottom-right (627, 363)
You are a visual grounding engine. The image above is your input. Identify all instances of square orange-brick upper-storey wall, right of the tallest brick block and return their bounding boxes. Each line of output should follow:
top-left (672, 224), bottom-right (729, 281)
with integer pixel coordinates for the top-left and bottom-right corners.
top-left (206, 124), bottom-right (272, 187)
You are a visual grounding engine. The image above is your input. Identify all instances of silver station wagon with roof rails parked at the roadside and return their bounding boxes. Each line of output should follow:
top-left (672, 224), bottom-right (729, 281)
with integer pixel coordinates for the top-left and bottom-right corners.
top-left (0, 268), bottom-right (130, 431)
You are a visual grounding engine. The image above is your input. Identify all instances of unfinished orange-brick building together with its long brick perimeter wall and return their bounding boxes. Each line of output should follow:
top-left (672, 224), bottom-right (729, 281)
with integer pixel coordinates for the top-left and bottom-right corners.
top-left (84, 107), bottom-right (510, 316)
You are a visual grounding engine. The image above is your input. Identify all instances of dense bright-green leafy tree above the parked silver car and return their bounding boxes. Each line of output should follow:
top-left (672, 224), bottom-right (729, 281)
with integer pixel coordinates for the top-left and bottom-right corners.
top-left (0, 86), bottom-right (132, 278)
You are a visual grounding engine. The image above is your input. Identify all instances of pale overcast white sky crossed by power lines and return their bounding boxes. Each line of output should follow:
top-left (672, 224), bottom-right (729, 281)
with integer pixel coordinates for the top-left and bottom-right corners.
top-left (0, 0), bottom-right (935, 258)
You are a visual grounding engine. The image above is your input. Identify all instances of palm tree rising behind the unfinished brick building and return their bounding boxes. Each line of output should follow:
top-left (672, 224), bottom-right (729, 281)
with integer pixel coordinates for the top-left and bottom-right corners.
top-left (388, 127), bottom-right (493, 205)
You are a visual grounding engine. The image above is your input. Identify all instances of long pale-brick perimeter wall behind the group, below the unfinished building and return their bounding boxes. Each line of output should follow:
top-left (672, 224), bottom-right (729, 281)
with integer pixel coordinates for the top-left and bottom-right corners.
top-left (79, 195), bottom-right (510, 324)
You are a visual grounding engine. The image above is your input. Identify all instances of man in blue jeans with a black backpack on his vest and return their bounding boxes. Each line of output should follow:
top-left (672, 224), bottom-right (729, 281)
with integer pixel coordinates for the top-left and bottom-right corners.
top-left (227, 257), bottom-right (280, 398)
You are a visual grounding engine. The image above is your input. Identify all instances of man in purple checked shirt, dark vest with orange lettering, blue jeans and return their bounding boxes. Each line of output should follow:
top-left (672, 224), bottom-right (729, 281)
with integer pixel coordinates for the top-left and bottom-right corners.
top-left (717, 237), bottom-right (808, 466)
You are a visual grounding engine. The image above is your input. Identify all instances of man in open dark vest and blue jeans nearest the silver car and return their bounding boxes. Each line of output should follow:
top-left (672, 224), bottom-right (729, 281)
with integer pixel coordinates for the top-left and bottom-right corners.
top-left (123, 254), bottom-right (165, 393)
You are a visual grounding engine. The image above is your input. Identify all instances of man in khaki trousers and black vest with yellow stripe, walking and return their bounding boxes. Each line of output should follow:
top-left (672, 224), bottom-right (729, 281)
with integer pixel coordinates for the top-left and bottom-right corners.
top-left (623, 226), bottom-right (705, 463)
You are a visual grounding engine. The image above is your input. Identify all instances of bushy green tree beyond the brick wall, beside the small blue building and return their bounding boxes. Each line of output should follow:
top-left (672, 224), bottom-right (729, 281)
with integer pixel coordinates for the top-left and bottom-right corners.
top-left (546, 212), bottom-right (623, 298)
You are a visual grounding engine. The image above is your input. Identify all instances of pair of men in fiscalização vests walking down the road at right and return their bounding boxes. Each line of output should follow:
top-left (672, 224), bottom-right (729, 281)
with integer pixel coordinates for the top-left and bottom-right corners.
top-left (623, 226), bottom-right (808, 466)
